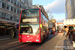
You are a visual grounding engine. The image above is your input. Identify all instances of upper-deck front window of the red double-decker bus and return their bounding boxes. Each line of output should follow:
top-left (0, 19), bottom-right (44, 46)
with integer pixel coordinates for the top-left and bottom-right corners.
top-left (21, 9), bottom-right (39, 17)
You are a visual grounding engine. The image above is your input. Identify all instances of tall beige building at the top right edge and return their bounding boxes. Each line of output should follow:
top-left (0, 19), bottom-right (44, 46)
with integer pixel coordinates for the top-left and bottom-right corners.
top-left (65, 0), bottom-right (75, 19)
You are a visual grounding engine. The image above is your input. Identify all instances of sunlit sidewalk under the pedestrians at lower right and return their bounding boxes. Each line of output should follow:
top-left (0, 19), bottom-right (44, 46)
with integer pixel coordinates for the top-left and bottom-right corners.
top-left (54, 33), bottom-right (75, 50)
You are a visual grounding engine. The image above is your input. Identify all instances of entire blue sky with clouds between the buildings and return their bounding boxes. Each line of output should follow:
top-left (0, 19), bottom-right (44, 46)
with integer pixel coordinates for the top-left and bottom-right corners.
top-left (33, 0), bottom-right (65, 20)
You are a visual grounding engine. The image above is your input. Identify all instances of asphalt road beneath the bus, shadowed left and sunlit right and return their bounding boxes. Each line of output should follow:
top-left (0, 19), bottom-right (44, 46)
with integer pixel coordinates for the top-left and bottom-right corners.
top-left (0, 34), bottom-right (74, 50)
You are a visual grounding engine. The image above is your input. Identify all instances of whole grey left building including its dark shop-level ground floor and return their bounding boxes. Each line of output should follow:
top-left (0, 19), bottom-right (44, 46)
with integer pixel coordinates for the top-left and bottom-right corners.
top-left (0, 0), bottom-right (32, 36)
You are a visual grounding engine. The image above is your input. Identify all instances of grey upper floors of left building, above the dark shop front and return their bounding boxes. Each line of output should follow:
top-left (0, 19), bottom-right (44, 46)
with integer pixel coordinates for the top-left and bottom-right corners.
top-left (0, 0), bottom-right (32, 24)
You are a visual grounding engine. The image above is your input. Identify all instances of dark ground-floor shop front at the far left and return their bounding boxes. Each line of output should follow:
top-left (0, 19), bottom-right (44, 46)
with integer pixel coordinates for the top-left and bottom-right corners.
top-left (0, 21), bottom-right (15, 36)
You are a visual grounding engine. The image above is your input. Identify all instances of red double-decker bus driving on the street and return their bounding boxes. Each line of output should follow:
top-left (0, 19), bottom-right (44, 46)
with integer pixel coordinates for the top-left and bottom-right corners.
top-left (18, 8), bottom-right (49, 43)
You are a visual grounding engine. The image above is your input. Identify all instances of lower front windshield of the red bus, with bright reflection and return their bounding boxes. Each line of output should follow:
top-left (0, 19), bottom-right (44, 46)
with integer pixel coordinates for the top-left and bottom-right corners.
top-left (20, 24), bottom-right (39, 34)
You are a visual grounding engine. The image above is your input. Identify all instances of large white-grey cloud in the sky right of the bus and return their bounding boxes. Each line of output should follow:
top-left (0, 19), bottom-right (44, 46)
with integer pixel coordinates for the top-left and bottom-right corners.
top-left (44, 0), bottom-right (65, 14)
